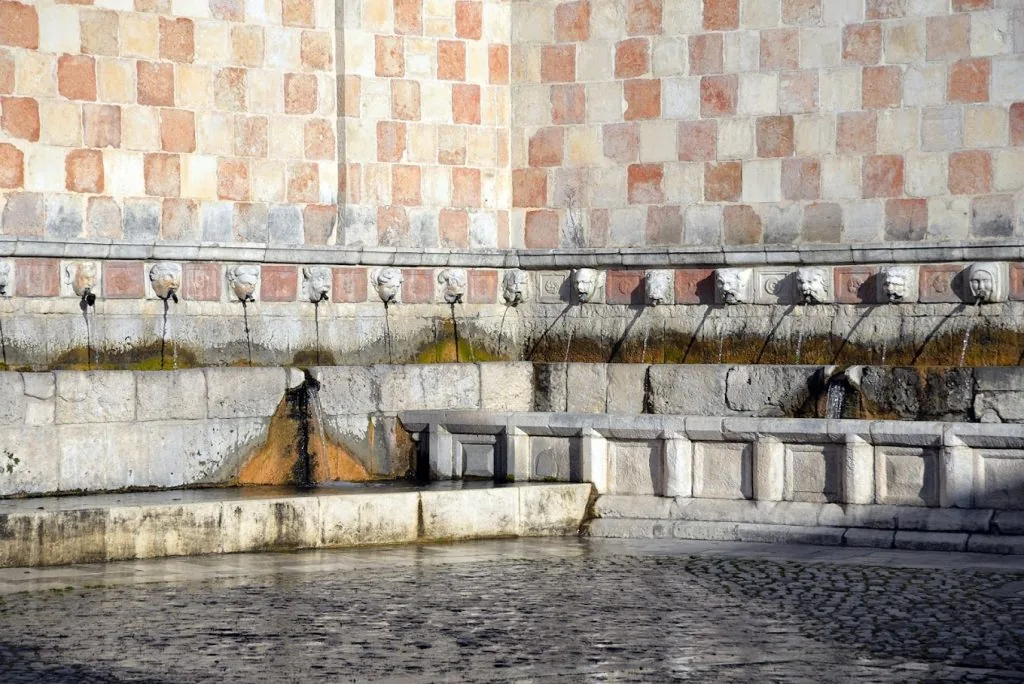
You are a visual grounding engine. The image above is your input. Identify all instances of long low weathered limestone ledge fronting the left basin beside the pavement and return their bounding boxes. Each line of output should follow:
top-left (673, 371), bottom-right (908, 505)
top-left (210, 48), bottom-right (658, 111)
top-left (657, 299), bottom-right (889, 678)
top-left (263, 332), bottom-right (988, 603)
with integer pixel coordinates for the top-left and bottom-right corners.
top-left (0, 483), bottom-right (592, 567)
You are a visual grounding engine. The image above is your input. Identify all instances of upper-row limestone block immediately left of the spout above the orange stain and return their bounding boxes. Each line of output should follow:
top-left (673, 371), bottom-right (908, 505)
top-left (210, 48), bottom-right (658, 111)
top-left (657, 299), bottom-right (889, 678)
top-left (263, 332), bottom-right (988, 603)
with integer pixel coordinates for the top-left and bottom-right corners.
top-left (204, 368), bottom-right (287, 418)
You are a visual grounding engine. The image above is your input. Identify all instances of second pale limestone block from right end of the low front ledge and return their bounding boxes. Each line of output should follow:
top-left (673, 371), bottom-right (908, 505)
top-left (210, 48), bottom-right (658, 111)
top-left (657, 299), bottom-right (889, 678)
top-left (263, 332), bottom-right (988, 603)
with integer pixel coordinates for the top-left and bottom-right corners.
top-left (420, 487), bottom-right (520, 540)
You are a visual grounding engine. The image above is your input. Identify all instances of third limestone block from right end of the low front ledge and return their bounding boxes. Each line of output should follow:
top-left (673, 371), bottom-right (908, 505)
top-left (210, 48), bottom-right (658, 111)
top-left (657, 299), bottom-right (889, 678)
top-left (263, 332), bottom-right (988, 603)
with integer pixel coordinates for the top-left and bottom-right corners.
top-left (321, 491), bottom-right (420, 547)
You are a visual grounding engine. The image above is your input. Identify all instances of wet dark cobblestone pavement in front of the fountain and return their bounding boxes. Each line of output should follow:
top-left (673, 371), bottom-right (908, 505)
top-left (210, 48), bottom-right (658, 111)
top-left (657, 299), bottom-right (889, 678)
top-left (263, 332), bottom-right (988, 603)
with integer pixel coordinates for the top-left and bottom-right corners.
top-left (0, 540), bottom-right (1024, 684)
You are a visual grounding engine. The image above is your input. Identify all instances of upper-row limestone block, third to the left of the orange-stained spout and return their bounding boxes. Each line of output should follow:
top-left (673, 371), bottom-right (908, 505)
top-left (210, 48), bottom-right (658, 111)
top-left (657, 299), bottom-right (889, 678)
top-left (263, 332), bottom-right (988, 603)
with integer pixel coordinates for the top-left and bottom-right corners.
top-left (53, 371), bottom-right (135, 424)
